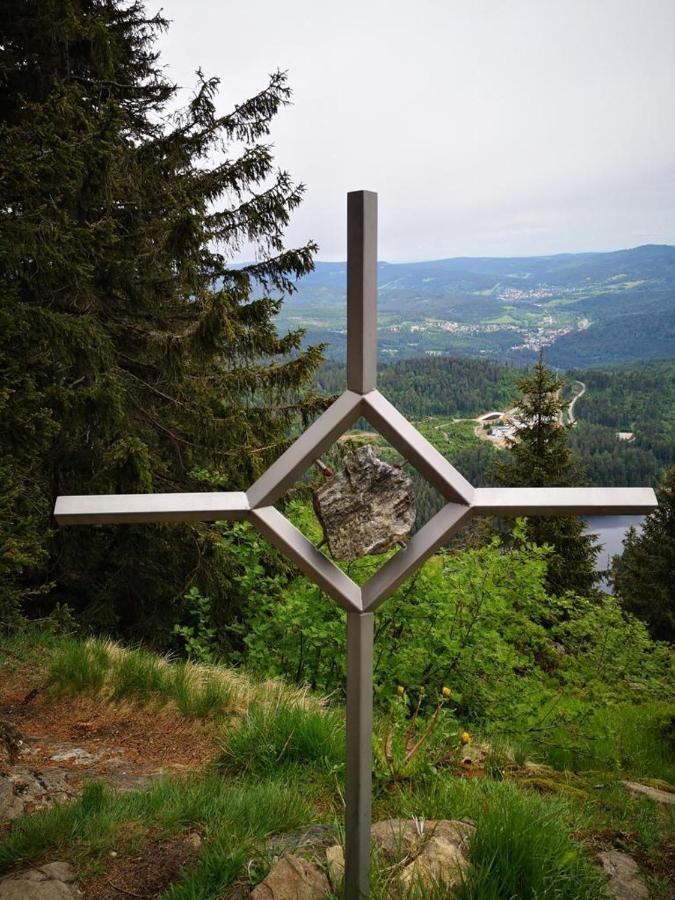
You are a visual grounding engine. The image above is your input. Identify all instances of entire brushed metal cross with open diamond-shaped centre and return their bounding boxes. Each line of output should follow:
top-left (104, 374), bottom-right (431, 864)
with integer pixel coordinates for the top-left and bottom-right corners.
top-left (54, 191), bottom-right (656, 900)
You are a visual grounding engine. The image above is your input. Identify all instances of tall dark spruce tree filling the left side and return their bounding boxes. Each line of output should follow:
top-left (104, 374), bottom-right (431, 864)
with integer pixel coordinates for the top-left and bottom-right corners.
top-left (0, 0), bottom-right (323, 640)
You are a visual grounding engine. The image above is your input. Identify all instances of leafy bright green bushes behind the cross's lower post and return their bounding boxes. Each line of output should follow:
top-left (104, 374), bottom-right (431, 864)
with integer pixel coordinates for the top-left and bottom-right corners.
top-left (230, 501), bottom-right (672, 771)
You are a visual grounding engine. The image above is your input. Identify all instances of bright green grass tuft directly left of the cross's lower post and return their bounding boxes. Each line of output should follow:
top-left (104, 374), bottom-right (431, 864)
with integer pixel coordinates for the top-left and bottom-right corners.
top-left (219, 701), bottom-right (345, 775)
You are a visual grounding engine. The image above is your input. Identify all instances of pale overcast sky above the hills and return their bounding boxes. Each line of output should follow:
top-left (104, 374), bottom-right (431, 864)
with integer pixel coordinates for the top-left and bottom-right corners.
top-left (156, 0), bottom-right (675, 261)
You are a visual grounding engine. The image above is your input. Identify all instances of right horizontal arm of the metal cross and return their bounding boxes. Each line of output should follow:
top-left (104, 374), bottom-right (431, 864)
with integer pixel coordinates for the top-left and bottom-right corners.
top-left (472, 487), bottom-right (658, 516)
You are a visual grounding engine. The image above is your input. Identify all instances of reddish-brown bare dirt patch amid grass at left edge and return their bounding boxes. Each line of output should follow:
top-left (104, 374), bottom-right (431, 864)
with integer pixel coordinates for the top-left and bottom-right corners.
top-left (0, 670), bottom-right (216, 822)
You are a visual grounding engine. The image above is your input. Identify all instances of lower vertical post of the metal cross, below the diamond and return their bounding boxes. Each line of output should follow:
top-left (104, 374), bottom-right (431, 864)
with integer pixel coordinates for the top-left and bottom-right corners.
top-left (345, 612), bottom-right (374, 900)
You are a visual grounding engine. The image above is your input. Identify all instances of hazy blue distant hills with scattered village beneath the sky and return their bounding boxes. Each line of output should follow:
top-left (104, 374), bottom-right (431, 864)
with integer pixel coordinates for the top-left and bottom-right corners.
top-left (278, 245), bottom-right (675, 367)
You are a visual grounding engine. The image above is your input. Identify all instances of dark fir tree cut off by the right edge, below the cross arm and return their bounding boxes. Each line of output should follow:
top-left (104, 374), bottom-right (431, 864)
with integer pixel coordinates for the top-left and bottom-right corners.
top-left (611, 467), bottom-right (675, 642)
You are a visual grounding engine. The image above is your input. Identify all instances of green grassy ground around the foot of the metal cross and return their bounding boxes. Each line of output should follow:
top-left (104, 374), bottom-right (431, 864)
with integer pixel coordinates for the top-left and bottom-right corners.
top-left (0, 636), bottom-right (675, 900)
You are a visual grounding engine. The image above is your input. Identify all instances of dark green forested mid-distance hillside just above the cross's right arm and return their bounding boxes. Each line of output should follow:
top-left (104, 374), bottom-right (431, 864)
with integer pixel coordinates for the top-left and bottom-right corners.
top-left (315, 357), bottom-right (675, 492)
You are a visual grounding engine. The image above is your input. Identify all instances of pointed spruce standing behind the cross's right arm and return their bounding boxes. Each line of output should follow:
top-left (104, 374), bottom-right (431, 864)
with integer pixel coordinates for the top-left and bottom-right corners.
top-left (496, 355), bottom-right (599, 595)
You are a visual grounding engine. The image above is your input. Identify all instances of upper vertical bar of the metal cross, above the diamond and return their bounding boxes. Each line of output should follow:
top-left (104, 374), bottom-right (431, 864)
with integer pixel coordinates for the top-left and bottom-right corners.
top-left (347, 191), bottom-right (377, 394)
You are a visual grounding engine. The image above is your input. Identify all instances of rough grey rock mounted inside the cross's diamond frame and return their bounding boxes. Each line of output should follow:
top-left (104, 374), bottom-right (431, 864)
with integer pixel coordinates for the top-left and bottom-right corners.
top-left (314, 445), bottom-right (415, 560)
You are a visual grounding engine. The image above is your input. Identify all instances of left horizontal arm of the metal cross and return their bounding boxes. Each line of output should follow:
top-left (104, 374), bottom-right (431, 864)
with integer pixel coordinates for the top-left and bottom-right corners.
top-left (54, 491), bottom-right (249, 525)
